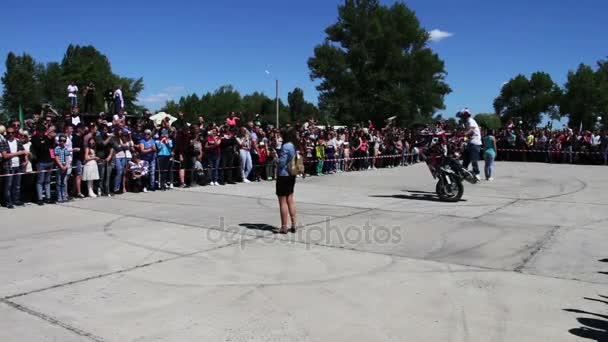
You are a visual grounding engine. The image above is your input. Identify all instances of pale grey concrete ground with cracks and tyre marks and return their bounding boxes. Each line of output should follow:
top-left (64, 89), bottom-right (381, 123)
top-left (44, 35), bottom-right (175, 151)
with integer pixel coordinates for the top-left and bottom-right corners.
top-left (0, 163), bottom-right (608, 342)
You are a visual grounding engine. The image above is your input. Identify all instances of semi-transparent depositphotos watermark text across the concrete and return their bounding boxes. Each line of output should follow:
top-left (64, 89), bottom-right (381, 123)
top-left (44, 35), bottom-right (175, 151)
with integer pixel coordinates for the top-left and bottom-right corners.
top-left (206, 217), bottom-right (404, 248)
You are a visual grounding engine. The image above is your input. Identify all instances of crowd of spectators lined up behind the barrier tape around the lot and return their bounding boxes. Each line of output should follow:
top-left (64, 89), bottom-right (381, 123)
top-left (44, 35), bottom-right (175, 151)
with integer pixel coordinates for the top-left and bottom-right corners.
top-left (0, 98), bottom-right (608, 208)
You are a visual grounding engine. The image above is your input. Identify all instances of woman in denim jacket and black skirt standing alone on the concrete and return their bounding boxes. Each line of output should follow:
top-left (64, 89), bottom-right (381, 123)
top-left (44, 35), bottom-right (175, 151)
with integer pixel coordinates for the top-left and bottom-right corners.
top-left (276, 128), bottom-right (298, 234)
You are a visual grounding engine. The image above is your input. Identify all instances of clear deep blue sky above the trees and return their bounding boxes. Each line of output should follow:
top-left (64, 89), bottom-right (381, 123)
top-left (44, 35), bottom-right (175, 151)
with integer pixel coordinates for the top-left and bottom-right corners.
top-left (0, 0), bottom-right (608, 120)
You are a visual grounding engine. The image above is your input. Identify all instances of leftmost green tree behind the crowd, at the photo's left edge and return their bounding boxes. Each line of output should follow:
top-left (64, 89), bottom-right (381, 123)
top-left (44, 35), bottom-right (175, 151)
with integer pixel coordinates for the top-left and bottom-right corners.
top-left (2, 52), bottom-right (40, 115)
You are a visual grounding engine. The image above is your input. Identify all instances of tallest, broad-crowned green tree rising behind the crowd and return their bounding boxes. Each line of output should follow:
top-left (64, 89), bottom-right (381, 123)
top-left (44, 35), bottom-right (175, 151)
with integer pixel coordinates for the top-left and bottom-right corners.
top-left (308, 0), bottom-right (451, 123)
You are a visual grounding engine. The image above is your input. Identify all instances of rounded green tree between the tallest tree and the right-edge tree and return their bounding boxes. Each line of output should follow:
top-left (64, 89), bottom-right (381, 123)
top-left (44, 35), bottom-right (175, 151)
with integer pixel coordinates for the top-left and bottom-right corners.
top-left (494, 72), bottom-right (561, 127)
